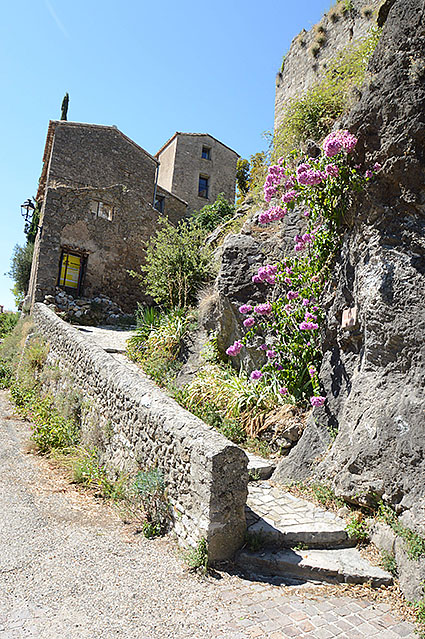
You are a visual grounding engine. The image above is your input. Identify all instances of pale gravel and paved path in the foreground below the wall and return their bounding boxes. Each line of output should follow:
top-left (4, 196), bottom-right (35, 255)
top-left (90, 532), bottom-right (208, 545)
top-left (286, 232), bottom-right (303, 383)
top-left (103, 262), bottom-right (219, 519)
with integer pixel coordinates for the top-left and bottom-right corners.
top-left (0, 392), bottom-right (416, 639)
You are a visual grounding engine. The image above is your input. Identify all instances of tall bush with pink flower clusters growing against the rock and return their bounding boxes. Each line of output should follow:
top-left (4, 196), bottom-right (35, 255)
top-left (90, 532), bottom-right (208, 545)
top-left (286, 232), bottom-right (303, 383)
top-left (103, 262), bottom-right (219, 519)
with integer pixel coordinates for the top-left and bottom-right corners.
top-left (227, 131), bottom-right (381, 407)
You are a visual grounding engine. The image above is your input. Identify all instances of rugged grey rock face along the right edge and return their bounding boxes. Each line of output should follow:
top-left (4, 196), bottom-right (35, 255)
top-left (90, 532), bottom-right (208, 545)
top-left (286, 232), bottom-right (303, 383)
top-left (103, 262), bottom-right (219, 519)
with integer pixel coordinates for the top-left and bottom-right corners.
top-left (274, 0), bottom-right (425, 533)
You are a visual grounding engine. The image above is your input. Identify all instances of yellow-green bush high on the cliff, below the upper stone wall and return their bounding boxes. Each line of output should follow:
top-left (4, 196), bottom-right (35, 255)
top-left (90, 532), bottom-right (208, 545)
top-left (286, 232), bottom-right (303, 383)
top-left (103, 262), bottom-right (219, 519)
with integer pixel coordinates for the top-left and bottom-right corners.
top-left (273, 29), bottom-right (380, 158)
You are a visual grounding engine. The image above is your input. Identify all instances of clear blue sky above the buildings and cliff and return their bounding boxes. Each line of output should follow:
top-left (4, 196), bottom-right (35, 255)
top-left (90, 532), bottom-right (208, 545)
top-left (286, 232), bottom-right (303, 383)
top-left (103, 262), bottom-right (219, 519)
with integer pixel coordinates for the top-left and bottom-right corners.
top-left (0, 0), bottom-right (332, 309)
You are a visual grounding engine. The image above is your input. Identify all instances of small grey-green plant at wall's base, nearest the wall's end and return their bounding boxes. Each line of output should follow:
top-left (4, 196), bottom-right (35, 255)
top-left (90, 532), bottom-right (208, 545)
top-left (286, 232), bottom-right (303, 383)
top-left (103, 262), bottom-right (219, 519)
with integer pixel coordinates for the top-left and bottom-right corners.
top-left (133, 468), bottom-right (171, 538)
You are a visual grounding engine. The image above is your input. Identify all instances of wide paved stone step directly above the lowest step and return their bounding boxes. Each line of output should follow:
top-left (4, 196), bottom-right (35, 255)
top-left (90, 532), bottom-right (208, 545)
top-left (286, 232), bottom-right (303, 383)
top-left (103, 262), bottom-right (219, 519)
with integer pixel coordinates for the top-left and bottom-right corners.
top-left (246, 481), bottom-right (355, 549)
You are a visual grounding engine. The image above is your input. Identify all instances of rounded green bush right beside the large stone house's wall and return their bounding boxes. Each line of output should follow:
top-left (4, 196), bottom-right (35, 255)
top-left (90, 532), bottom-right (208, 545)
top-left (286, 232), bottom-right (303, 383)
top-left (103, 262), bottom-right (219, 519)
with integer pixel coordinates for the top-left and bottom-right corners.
top-left (130, 217), bottom-right (211, 308)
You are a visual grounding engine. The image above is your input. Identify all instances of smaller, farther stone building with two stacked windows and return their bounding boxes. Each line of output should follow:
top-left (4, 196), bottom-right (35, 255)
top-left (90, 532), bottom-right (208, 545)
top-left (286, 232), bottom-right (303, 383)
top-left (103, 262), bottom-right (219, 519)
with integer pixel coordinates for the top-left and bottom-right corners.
top-left (155, 132), bottom-right (239, 211)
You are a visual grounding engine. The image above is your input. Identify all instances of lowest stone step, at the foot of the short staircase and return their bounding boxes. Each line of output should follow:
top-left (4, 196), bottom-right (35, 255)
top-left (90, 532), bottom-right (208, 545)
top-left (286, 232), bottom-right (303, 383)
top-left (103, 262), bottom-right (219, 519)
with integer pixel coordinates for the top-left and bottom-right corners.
top-left (236, 548), bottom-right (393, 587)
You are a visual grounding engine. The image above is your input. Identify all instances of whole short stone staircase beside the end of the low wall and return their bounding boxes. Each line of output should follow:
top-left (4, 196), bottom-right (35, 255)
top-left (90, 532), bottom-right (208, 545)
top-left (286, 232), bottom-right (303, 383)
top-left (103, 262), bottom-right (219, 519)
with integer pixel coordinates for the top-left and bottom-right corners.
top-left (236, 476), bottom-right (392, 587)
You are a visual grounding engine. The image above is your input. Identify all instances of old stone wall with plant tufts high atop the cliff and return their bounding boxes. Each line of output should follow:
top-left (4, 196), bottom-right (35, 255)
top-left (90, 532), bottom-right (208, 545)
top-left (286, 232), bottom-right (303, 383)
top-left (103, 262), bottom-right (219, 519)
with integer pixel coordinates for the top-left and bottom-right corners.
top-left (275, 0), bottom-right (380, 129)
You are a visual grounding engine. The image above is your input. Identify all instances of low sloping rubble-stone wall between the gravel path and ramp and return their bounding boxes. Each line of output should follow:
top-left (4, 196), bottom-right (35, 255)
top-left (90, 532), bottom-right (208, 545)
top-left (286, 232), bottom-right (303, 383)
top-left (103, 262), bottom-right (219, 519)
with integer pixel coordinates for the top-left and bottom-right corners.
top-left (33, 303), bottom-right (248, 561)
